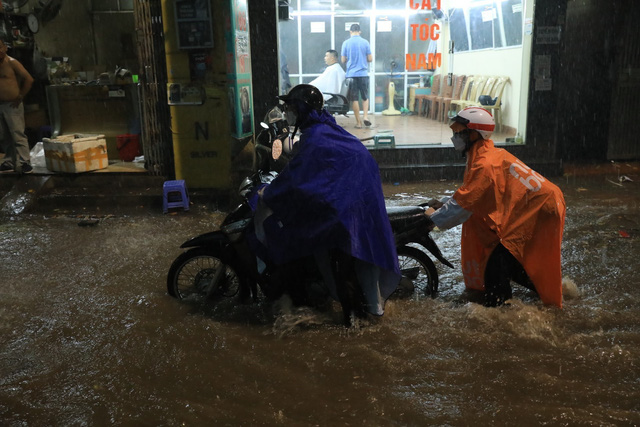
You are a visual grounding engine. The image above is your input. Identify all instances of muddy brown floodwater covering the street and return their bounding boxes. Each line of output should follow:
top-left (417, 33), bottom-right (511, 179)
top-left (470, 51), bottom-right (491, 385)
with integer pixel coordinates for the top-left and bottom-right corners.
top-left (0, 176), bottom-right (640, 426)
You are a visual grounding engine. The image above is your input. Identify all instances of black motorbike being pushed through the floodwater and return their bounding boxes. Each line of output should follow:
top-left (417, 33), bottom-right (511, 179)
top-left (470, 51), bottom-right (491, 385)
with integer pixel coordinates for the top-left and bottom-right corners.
top-left (167, 108), bottom-right (453, 324)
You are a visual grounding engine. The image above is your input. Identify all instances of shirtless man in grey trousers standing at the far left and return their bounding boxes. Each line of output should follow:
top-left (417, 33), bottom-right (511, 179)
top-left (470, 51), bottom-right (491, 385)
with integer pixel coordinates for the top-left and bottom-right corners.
top-left (0, 39), bottom-right (33, 173)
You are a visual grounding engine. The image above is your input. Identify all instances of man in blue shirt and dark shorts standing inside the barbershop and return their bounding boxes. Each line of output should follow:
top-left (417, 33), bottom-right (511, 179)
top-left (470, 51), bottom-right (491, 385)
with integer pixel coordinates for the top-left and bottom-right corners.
top-left (342, 24), bottom-right (373, 129)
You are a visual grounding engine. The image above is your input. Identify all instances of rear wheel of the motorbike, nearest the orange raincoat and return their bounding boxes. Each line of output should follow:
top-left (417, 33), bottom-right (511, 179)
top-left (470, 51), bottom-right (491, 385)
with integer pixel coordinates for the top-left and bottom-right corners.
top-left (398, 246), bottom-right (438, 298)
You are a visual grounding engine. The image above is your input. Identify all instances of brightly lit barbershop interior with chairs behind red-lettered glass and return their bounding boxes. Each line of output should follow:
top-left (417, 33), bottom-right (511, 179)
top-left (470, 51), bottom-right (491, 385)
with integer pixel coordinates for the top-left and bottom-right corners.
top-left (278, 0), bottom-right (532, 146)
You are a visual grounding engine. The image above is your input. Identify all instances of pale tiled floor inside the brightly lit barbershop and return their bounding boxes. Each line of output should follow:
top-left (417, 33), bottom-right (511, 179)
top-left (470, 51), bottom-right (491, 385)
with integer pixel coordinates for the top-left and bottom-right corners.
top-left (335, 112), bottom-right (514, 146)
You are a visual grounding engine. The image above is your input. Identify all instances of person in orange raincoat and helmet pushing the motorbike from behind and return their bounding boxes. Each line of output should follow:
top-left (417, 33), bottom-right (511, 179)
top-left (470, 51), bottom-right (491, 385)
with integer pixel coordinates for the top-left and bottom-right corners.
top-left (426, 107), bottom-right (565, 307)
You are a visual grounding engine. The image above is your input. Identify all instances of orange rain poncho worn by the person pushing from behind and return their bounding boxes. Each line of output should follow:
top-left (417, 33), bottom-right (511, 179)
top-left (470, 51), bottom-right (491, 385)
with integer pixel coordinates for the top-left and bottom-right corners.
top-left (453, 140), bottom-right (565, 307)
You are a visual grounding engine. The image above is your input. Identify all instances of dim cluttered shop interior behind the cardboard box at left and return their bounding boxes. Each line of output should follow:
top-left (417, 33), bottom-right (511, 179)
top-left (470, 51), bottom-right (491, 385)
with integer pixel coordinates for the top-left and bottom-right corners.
top-left (0, 0), bottom-right (144, 172)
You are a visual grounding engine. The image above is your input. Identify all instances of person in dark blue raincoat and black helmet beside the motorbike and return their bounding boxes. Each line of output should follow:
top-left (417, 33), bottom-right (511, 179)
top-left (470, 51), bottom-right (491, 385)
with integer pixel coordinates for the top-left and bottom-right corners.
top-left (256, 84), bottom-right (401, 322)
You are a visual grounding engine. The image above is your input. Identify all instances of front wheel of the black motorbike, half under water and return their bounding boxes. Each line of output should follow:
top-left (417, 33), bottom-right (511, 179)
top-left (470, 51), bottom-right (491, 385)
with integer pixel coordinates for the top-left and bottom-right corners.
top-left (167, 248), bottom-right (241, 300)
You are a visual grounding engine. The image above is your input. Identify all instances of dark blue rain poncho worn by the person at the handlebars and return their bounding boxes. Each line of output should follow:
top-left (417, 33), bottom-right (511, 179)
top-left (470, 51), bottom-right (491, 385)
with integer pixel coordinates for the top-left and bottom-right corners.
top-left (262, 110), bottom-right (400, 299)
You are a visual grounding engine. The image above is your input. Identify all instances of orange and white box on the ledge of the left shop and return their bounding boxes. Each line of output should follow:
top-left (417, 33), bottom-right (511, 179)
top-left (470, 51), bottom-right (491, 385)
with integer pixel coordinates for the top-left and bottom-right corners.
top-left (42, 134), bottom-right (109, 173)
